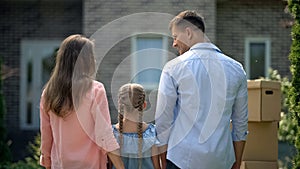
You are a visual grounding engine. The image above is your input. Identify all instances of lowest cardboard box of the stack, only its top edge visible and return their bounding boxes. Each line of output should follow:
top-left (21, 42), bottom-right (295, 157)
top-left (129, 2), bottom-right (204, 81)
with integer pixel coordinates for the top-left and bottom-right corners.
top-left (241, 161), bottom-right (278, 169)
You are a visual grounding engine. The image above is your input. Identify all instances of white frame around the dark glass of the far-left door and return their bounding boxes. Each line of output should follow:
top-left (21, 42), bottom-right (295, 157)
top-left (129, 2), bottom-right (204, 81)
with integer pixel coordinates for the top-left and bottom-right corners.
top-left (19, 40), bottom-right (61, 130)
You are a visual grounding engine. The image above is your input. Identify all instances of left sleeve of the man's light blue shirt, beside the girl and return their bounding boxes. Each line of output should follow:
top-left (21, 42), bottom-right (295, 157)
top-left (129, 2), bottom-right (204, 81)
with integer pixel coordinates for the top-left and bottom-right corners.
top-left (155, 70), bottom-right (177, 146)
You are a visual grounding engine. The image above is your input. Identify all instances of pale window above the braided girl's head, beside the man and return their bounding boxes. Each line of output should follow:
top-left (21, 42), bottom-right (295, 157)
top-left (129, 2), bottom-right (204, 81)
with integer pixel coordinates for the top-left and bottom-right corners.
top-left (131, 35), bottom-right (168, 90)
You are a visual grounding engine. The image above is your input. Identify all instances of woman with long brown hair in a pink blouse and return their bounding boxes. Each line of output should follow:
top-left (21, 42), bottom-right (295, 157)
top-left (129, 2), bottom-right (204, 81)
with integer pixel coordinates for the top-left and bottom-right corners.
top-left (40, 35), bottom-right (124, 169)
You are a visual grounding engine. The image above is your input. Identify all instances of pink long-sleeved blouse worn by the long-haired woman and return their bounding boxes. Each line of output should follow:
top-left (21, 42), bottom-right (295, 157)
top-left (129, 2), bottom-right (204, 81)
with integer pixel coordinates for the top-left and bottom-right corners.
top-left (40, 81), bottom-right (119, 169)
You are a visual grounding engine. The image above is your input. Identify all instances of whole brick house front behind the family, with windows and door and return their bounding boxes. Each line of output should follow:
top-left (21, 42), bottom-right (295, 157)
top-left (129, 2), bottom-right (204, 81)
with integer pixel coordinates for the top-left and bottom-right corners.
top-left (0, 0), bottom-right (291, 159)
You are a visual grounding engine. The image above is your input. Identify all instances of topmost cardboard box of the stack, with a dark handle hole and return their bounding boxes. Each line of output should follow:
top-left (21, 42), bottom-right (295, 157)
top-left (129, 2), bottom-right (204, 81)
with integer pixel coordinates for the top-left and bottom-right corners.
top-left (248, 80), bottom-right (281, 122)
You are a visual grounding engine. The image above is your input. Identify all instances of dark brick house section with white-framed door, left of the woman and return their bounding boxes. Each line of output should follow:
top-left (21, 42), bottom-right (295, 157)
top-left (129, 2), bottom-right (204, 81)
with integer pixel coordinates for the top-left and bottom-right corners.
top-left (0, 0), bottom-right (83, 160)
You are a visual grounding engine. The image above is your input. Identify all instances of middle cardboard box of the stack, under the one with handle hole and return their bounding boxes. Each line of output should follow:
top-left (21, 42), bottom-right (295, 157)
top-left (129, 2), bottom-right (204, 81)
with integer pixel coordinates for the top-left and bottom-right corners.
top-left (243, 122), bottom-right (278, 161)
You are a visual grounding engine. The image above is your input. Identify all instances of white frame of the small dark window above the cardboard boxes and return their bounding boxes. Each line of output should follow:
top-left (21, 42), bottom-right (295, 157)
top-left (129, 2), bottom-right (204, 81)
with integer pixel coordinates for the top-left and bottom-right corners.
top-left (245, 37), bottom-right (271, 79)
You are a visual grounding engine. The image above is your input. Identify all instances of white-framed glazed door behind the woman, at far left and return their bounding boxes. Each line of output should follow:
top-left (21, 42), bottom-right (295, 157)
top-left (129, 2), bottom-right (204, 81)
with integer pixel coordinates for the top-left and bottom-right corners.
top-left (20, 40), bottom-right (60, 129)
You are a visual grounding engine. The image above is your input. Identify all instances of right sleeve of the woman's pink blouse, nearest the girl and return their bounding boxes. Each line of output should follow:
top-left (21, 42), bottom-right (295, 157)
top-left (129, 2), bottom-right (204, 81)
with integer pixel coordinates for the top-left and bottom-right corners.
top-left (92, 83), bottom-right (119, 152)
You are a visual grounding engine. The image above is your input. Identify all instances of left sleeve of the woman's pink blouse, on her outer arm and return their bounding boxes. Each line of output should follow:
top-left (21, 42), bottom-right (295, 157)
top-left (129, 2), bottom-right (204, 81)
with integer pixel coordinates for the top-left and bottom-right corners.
top-left (40, 94), bottom-right (53, 167)
